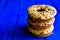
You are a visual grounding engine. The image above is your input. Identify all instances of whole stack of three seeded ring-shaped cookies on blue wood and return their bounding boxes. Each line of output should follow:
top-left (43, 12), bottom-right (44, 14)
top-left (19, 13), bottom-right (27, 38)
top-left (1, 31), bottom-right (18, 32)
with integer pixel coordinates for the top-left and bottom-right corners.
top-left (28, 4), bottom-right (56, 37)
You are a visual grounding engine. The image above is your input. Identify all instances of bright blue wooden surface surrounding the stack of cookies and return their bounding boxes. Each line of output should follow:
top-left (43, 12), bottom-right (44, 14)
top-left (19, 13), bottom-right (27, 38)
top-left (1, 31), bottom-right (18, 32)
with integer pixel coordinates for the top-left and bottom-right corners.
top-left (0, 0), bottom-right (60, 40)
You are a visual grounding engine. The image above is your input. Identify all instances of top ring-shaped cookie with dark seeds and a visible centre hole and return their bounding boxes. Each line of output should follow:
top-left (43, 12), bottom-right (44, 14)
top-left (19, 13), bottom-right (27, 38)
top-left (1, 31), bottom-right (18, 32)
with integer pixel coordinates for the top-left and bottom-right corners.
top-left (28, 4), bottom-right (57, 20)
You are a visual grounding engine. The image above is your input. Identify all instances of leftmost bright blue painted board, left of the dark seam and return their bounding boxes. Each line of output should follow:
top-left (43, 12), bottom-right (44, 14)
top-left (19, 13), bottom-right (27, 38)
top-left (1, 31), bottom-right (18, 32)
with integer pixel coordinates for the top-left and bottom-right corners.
top-left (0, 0), bottom-right (20, 40)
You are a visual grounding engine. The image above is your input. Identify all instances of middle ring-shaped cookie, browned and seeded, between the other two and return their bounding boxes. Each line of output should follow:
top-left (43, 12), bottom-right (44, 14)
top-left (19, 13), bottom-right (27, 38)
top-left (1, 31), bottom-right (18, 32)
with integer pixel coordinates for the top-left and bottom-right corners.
top-left (28, 18), bottom-right (55, 27)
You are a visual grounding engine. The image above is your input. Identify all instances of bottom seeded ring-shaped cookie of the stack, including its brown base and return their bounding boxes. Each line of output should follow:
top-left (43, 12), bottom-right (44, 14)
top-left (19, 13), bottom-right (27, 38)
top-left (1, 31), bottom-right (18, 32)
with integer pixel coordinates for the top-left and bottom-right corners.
top-left (28, 25), bottom-right (54, 37)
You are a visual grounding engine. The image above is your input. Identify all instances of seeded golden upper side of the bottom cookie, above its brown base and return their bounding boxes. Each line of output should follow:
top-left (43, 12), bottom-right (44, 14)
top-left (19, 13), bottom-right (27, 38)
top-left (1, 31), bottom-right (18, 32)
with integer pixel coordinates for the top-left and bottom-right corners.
top-left (28, 25), bottom-right (54, 35)
